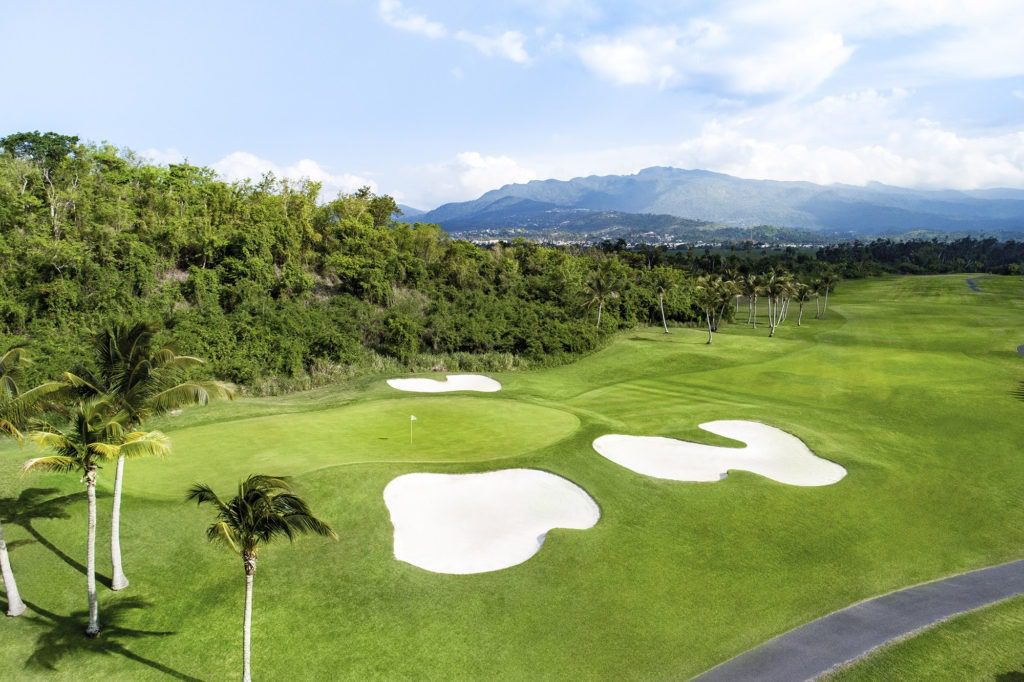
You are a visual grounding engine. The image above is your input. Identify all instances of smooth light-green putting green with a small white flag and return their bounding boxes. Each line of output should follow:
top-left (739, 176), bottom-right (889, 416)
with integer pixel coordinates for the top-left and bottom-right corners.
top-left (123, 395), bottom-right (580, 499)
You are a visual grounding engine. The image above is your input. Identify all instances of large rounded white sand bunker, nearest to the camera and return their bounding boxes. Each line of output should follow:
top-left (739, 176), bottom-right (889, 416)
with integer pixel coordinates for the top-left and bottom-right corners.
top-left (384, 469), bottom-right (601, 574)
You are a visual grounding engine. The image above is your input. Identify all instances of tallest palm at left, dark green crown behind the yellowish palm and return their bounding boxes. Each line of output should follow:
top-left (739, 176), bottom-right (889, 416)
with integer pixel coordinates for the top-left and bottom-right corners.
top-left (65, 323), bottom-right (234, 590)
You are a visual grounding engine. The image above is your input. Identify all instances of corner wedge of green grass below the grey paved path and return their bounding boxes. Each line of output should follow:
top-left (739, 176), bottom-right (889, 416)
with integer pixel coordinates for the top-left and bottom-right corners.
top-left (828, 597), bottom-right (1024, 682)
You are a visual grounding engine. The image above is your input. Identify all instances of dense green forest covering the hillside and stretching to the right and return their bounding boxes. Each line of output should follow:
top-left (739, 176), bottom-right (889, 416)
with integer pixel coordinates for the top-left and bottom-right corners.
top-left (0, 132), bottom-right (1024, 392)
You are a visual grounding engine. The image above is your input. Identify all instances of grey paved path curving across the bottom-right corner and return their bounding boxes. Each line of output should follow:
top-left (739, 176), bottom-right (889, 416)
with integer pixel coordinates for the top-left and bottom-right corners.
top-left (696, 560), bottom-right (1024, 682)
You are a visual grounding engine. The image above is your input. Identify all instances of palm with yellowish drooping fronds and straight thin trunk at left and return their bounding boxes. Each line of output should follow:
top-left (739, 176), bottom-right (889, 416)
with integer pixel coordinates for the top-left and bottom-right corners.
top-left (23, 398), bottom-right (171, 637)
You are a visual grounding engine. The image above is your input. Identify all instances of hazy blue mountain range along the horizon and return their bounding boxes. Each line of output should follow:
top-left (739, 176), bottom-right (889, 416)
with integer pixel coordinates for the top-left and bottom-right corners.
top-left (403, 167), bottom-right (1024, 237)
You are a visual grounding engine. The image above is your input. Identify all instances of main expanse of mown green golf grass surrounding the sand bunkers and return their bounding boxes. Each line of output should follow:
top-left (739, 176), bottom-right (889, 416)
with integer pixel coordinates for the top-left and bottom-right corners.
top-left (0, 275), bottom-right (1024, 680)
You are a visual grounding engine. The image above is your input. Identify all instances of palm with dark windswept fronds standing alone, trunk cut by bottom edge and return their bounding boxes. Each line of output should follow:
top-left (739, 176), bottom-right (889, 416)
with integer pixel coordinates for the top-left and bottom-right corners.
top-left (185, 474), bottom-right (338, 682)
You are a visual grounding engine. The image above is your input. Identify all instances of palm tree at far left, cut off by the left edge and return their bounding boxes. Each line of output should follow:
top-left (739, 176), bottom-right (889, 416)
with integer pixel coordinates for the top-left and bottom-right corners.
top-left (0, 345), bottom-right (61, 617)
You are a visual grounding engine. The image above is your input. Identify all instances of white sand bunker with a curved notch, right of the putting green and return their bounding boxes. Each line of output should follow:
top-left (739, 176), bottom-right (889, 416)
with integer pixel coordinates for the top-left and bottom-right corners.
top-left (594, 420), bottom-right (846, 485)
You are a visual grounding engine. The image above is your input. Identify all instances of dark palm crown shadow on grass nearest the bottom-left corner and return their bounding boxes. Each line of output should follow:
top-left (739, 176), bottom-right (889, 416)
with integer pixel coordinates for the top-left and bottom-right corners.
top-left (22, 597), bottom-right (200, 682)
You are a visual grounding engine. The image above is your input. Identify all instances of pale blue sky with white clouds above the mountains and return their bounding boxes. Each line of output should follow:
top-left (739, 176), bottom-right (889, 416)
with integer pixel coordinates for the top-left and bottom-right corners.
top-left (0, 0), bottom-right (1024, 208)
